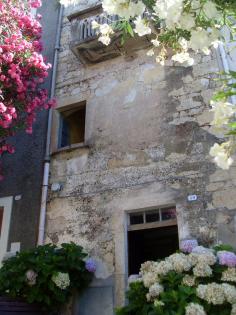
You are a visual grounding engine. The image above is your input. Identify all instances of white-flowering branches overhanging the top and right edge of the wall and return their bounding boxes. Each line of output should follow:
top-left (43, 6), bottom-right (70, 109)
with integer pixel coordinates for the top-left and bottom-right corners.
top-left (59, 0), bottom-right (236, 170)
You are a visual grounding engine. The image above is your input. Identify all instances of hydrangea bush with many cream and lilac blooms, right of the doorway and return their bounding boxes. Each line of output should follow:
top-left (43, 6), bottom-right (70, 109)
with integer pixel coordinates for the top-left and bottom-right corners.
top-left (117, 240), bottom-right (236, 315)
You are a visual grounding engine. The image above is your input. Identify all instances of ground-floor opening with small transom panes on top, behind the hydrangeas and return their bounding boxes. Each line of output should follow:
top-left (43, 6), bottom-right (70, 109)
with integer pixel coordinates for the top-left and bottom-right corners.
top-left (128, 207), bottom-right (179, 275)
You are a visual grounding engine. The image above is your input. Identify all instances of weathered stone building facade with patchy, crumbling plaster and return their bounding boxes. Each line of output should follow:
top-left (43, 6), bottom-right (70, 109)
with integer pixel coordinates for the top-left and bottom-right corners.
top-left (46, 1), bottom-right (236, 315)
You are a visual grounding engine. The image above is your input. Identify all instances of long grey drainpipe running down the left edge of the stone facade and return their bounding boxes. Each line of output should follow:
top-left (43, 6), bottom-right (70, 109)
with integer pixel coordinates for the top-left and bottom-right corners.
top-left (38, 5), bottom-right (64, 245)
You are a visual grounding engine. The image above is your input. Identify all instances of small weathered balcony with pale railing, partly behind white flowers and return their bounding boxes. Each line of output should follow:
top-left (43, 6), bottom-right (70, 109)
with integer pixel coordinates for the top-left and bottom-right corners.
top-left (68, 6), bottom-right (153, 64)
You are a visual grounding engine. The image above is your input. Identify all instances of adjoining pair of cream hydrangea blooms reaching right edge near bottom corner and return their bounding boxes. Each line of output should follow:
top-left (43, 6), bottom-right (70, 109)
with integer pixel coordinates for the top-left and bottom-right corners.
top-left (197, 282), bottom-right (236, 305)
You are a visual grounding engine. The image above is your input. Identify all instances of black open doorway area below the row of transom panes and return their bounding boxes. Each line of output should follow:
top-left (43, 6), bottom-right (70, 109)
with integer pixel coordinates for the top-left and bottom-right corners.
top-left (128, 225), bottom-right (179, 275)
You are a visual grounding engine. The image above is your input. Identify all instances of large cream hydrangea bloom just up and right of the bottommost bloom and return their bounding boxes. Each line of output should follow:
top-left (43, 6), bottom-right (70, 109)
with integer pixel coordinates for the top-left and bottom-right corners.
top-left (197, 282), bottom-right (225, 305)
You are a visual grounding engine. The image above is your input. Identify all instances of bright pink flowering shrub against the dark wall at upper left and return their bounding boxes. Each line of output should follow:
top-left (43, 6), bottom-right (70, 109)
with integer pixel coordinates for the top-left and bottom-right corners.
top-left (0, 0), bottom-right (54, 177)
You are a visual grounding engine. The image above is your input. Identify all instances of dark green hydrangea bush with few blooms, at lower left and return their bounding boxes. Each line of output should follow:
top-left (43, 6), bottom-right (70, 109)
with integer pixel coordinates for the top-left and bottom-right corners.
top-left (0, 243), bottom-right (96, 311)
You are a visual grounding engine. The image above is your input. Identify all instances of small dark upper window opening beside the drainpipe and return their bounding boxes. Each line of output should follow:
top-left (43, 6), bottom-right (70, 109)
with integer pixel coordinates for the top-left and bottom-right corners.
top-left (59, 104), bottom-right (86, 148)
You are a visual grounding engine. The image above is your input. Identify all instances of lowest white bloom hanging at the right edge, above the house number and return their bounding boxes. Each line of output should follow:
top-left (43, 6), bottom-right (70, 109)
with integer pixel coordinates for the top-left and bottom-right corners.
top-left (210, 142), bottom-right (233, 170)
